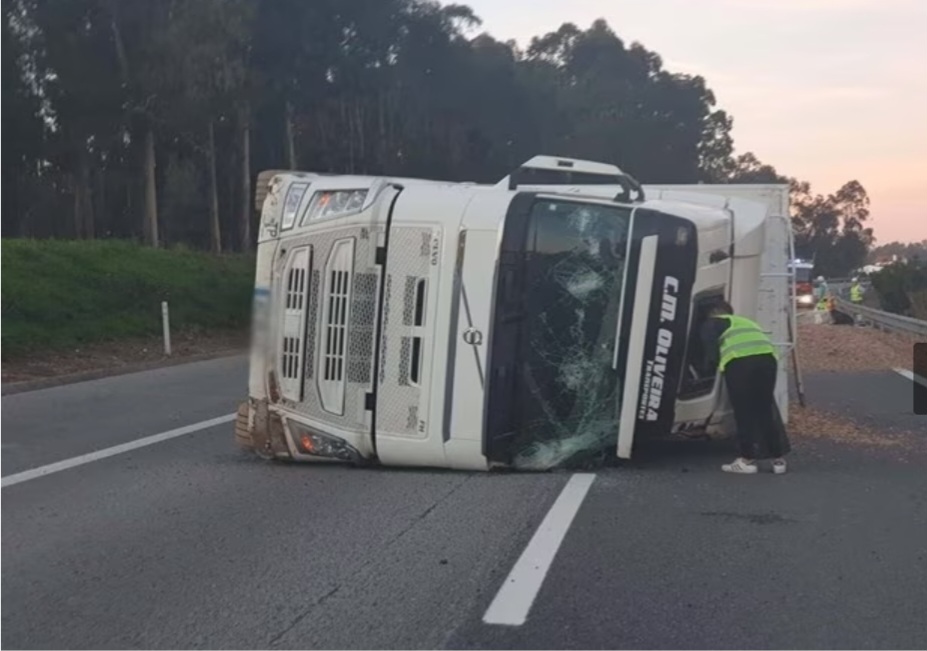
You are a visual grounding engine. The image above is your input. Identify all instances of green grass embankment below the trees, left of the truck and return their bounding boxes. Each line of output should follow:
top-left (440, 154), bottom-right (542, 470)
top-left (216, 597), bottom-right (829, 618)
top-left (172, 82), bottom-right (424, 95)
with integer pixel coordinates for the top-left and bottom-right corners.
top-left (2, 239), bottom-right (254, 360)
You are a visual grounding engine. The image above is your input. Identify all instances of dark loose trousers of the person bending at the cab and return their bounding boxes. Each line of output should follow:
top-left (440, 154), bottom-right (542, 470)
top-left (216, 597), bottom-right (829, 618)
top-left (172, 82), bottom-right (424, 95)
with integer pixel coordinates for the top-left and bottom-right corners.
top-left (724, 355), bottom-right (791, 459)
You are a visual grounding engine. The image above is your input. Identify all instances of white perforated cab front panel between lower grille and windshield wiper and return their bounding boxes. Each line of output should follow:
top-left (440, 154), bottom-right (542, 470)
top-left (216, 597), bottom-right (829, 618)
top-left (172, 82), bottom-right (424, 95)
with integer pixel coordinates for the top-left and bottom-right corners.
top-left (372, 185), bottom-right (474, 465)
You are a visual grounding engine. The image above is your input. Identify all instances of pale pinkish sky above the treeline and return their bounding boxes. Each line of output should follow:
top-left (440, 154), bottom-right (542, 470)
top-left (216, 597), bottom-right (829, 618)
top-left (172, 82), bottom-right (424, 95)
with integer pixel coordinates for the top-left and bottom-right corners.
top-left (457, 0), bottom-right (927, 244)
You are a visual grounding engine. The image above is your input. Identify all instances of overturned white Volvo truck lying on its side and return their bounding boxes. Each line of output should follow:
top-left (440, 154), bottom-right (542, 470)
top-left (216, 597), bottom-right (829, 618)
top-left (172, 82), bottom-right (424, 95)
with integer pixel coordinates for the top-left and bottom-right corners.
top-left (235, 156), bottom-right (795, 470)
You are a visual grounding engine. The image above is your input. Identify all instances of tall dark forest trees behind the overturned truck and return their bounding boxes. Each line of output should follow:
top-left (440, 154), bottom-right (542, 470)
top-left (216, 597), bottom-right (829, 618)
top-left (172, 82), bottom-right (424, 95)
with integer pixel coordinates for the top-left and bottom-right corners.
top-left (2, 0), bottom-right (888, 275)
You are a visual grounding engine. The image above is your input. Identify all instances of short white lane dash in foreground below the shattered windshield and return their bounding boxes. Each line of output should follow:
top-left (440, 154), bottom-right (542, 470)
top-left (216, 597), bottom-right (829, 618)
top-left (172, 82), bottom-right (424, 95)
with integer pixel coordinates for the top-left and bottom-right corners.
top-left (483, 473), bottom-right (595, 626)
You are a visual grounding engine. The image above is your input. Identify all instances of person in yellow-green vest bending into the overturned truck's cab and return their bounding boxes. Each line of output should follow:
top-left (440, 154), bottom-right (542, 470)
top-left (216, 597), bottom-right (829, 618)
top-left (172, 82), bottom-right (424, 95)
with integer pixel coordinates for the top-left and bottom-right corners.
top-left (701, 301), bottom-right (791, 475)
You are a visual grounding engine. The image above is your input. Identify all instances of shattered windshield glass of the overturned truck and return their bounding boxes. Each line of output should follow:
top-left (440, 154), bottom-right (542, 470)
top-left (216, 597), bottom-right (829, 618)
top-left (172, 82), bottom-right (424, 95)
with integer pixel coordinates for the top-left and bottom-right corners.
top-left (492, 200), bottom-right (631, 469)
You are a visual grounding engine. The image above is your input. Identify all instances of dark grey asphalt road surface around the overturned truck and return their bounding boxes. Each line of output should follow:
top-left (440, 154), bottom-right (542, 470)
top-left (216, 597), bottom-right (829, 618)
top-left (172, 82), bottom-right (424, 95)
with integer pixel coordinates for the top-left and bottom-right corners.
top-left (0, 359), bottom-right (927, 649)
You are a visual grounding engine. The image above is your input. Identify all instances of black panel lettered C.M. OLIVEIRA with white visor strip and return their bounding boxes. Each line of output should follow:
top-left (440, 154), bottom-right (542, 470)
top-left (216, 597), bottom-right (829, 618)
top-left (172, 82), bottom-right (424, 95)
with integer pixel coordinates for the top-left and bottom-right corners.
top-left (615, 206), bottom-right (698, 459)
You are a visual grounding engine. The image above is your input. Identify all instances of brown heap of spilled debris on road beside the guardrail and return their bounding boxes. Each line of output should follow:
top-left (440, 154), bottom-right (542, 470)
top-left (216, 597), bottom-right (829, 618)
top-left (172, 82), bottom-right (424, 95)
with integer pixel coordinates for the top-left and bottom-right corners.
top-left (798, 324), bottom-right (916, 372)
